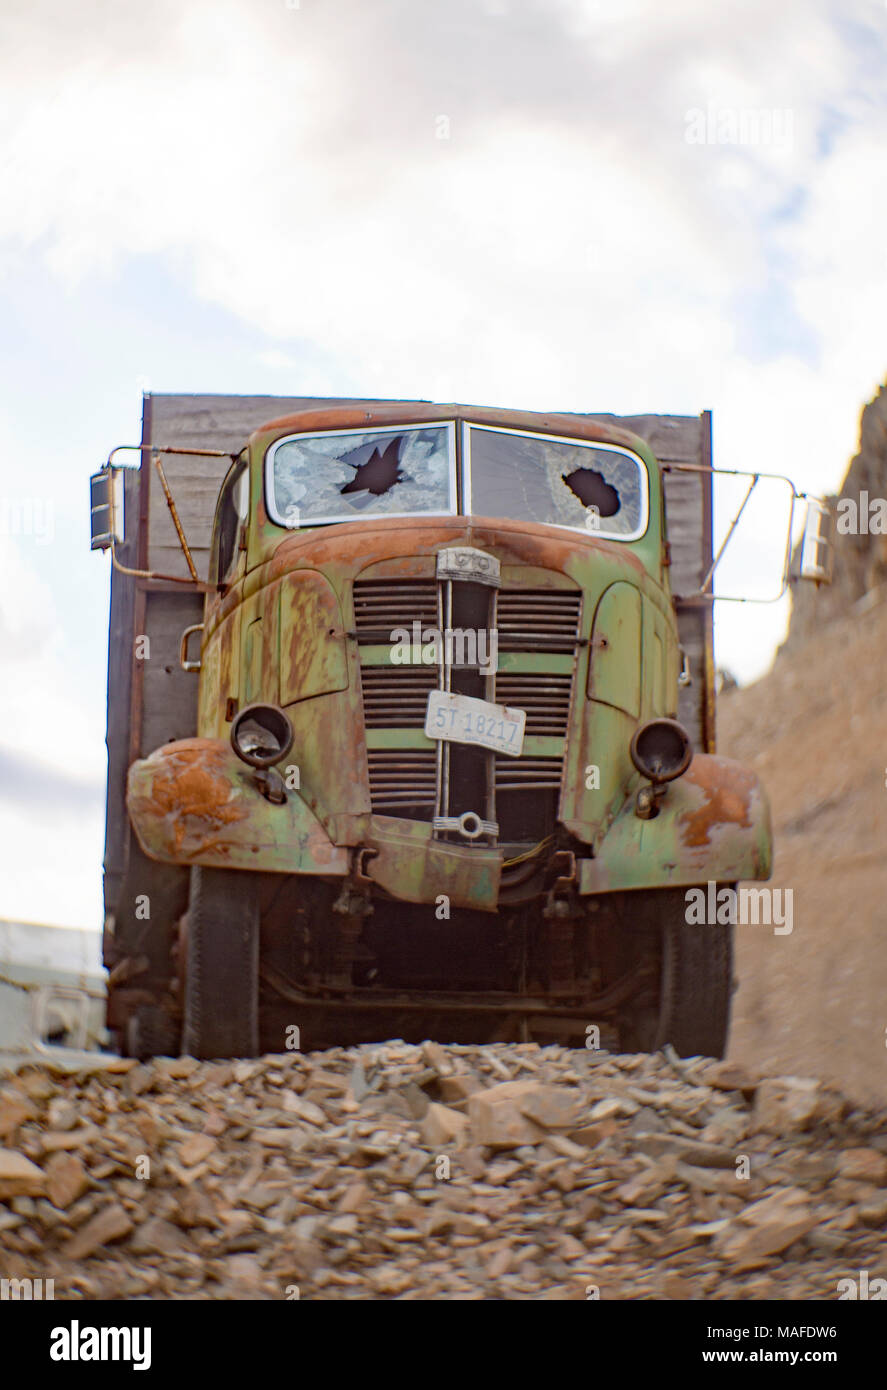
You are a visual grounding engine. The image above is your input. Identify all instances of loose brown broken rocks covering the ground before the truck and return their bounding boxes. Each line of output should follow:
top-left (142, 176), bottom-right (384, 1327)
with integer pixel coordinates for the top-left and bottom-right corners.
top-left (0, 1043), bottom-right (887, 1300)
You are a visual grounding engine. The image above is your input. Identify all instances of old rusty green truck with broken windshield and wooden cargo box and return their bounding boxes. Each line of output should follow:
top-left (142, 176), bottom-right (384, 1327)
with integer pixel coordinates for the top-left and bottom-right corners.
top-left (93, 396), bottom-right (828, 1056)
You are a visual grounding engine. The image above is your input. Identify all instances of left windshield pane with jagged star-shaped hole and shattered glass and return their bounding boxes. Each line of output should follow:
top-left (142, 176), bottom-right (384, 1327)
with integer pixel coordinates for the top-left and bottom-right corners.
top-left (268, 425), bottom-right (456, 527)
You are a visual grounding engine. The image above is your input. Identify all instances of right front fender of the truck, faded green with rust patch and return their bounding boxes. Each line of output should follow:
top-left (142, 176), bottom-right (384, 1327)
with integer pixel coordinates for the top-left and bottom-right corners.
top-left (580, 753), bottom-right (772, 894)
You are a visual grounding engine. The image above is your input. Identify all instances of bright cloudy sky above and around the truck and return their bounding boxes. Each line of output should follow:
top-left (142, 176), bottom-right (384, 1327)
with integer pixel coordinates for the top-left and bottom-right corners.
top-left (0, 0), bottom-right (887, 927)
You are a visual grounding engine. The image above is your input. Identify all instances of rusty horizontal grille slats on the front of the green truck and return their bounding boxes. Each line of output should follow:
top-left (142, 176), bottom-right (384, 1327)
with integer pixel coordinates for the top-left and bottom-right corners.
top-left (355, 580), bottom-right (581, 820)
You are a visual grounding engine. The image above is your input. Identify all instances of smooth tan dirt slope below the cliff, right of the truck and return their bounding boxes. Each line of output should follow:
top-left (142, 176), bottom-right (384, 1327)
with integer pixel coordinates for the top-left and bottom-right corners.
top-left (717, 599), bottom-right (887, 1104)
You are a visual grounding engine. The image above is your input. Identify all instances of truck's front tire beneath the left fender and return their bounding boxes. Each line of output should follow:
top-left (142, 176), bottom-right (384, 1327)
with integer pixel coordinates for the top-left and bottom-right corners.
top-left (182, 866), bottom-right (259, 1058)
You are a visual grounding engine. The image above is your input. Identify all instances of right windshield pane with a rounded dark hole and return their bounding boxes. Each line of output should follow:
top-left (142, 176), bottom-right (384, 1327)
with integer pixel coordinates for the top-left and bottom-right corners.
top-left (466, 425), bottom-right (646, 541)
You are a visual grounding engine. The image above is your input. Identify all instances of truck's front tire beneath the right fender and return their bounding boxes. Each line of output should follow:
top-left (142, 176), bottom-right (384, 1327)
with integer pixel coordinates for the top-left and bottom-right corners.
top-left (621, 884), bottom-right (733, 1058)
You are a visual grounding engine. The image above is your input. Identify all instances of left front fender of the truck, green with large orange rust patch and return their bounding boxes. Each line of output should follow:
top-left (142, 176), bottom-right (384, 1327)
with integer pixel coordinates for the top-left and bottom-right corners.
top-left (127, 738), bottom-right (349, 876)
